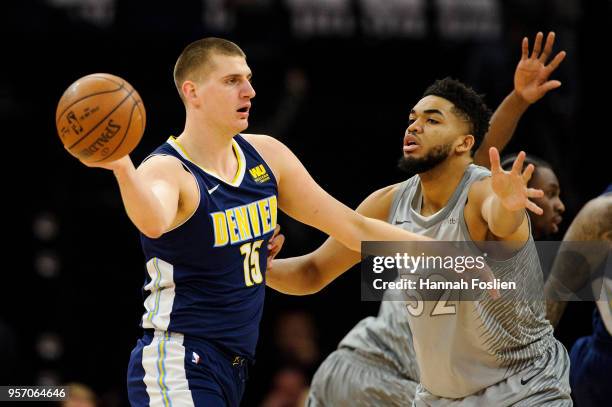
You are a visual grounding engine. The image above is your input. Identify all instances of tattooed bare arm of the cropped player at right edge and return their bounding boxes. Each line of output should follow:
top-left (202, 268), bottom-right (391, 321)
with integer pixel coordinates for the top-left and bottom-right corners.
top-left (544, 196), bottom-right (612, 327)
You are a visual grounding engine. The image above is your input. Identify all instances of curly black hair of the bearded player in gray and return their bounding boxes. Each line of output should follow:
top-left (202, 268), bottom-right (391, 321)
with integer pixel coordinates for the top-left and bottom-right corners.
top-left (423, 77), bottom-right (492, 152)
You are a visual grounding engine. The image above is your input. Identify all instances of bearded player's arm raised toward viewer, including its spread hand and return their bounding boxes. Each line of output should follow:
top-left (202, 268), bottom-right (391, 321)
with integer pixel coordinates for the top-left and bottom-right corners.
top-left (465, 147), bottom-right (543, 242)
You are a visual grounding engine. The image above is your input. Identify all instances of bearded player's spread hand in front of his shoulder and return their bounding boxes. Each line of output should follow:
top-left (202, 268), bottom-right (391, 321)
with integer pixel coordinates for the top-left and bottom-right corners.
top-left (489, 147), bottom-right (544, 215)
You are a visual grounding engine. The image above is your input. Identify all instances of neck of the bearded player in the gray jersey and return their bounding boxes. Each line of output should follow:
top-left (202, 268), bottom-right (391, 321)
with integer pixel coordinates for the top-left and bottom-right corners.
top-left (419, 157), bottom-right (470, 216)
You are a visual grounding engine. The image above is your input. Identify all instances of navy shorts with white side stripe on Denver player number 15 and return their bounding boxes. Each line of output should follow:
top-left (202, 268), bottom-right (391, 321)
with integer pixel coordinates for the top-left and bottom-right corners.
top-left (127, 331), bottom-right (248, 407)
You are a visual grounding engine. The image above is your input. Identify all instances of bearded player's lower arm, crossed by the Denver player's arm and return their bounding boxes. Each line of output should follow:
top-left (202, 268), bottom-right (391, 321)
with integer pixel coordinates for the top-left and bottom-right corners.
top-left (266, 184), bottom-right (399, 295)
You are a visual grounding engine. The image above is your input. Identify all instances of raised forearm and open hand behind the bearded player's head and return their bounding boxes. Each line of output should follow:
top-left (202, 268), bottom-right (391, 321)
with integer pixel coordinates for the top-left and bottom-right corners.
top-left (474, 32), bottom-right (566, 167)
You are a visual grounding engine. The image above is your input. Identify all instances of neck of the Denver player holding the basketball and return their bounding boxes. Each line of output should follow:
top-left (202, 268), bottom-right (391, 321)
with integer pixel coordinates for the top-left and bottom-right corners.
top-left (176, 120), bottom-right (238, 180)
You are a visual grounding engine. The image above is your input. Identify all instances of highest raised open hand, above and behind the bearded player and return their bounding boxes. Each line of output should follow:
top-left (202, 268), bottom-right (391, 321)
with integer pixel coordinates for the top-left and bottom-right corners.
top-left (514, 32), bottom-right (566, 104)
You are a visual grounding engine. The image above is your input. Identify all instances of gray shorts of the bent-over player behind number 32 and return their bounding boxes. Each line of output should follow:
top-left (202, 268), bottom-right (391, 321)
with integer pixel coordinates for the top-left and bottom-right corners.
top-left (306, 349), bottom-right (417, 407)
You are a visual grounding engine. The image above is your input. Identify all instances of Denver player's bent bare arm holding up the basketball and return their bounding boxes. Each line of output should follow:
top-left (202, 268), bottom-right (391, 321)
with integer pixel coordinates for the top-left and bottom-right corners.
top-left (85, 155), bottom-right (188, 238)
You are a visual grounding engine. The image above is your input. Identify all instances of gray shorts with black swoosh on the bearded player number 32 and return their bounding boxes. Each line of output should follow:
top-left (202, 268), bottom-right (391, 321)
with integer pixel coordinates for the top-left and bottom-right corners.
top-left (414, 341), bottom-right (572, 407)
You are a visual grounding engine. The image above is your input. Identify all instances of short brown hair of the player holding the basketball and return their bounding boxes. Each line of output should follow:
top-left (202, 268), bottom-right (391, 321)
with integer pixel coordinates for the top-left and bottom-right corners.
top-left (174, 37), bottom-right (246, 99)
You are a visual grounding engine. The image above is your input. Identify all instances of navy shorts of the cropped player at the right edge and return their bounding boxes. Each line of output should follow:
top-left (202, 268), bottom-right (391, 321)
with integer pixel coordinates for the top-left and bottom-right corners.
top-left (570, 309), bottom-right (612, 407)
